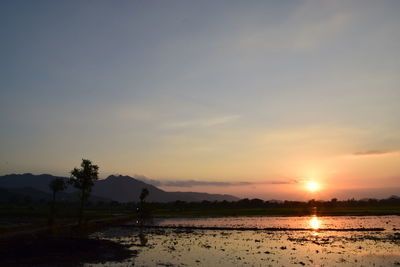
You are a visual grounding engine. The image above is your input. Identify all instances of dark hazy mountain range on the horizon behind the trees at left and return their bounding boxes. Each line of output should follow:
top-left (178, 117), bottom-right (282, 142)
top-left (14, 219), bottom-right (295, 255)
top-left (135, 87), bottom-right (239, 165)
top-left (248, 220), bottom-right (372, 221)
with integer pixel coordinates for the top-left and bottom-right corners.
top-left (0, 173), bottom-right (239, 202)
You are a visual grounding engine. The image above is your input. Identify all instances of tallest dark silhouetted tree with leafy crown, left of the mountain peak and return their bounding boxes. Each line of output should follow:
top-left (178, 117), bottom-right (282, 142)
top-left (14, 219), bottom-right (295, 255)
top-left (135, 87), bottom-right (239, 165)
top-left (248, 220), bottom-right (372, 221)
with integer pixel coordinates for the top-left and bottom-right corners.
top-left (70, 159), bottom-right (99, 226)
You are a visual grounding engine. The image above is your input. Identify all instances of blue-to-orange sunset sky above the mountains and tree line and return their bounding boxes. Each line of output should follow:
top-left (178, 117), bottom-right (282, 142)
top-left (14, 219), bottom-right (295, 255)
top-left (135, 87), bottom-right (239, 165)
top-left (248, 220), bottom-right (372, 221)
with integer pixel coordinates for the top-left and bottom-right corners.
top-left (0, 0), bottom-right (400, 200)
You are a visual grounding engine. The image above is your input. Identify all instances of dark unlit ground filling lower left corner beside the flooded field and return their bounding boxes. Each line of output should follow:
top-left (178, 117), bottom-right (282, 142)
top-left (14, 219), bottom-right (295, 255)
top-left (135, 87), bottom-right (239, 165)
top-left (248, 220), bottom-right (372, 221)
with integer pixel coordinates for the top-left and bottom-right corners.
top-left (0, 216), bottom-right (136, 266)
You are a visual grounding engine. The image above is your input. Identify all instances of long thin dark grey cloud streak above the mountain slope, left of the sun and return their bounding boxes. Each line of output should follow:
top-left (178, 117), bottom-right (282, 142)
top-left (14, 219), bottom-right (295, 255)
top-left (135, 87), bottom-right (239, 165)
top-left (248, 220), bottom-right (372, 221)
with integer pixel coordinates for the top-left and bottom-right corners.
top-left (135, 175), bottom-right (298, 187)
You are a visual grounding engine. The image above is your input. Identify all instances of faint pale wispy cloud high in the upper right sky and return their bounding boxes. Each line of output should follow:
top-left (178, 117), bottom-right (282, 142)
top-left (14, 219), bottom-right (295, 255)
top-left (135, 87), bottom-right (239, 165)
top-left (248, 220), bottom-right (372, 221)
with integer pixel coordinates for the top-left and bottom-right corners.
top-left (235, 6), bottom-right (356, 56)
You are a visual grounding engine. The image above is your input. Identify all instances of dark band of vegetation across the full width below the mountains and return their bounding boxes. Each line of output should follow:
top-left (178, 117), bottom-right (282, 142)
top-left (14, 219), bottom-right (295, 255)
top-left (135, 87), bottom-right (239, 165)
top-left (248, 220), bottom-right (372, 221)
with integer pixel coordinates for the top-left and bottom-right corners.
top-left (0, 197), bottom-right (400, 229)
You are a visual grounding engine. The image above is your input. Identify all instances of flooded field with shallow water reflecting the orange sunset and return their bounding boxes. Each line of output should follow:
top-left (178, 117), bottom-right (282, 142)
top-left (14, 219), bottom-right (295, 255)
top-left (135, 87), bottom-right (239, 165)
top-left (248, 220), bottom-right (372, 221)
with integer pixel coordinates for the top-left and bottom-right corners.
top-left (87, 216), bottom-right (400, 266)
